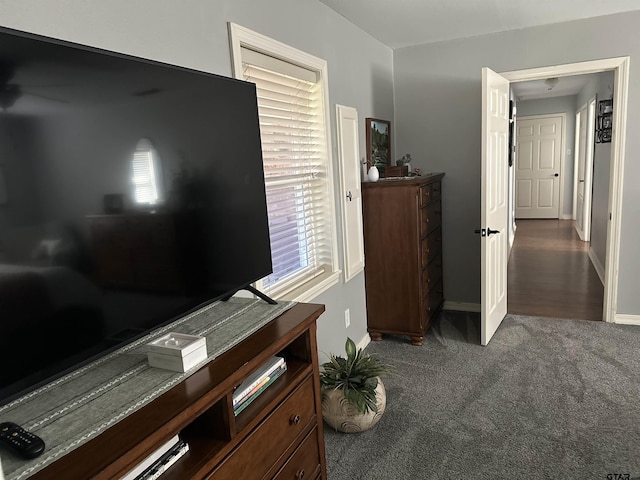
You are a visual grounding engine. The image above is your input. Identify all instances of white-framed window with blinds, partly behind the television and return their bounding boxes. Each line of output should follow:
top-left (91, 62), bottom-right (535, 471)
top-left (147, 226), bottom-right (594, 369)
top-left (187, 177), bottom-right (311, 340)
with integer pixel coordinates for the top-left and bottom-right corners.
top-left (230, 24), bottom-right (339, 301)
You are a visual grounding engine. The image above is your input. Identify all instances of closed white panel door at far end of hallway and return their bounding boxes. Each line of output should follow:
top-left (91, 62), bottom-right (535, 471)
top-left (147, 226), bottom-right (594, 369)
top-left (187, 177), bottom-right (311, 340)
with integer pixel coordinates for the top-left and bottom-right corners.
top-left (515, 115), bottom-right (564, 218)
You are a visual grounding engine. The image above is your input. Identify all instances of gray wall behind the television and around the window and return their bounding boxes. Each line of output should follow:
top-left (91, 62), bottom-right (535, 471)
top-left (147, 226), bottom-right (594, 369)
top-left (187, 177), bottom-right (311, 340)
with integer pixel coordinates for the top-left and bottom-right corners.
top-left (0, 0), bottom-right (394, 360)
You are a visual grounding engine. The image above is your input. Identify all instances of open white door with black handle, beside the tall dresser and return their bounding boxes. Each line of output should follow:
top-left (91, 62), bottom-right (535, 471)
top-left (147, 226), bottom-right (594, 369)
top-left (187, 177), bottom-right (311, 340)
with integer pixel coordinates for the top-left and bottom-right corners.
top-left (480, 68), bottom-right (509, 345)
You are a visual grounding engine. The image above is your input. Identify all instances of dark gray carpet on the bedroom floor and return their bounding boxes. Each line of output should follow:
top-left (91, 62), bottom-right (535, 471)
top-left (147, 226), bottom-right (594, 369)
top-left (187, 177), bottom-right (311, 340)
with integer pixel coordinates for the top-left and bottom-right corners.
top-left (324, 312), bottom-right (640, 480)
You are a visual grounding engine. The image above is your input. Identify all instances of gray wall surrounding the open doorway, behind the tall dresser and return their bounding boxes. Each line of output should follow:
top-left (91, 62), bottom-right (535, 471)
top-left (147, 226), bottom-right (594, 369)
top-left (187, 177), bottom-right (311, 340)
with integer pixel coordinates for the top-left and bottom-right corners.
top-left (394, 12), bottom-right (640, 314)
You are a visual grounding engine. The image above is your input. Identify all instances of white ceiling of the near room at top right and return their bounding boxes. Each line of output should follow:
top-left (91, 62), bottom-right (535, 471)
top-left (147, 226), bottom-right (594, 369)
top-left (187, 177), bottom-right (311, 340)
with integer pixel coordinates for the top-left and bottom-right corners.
top-left (320, 0), bottom-right (640, 49)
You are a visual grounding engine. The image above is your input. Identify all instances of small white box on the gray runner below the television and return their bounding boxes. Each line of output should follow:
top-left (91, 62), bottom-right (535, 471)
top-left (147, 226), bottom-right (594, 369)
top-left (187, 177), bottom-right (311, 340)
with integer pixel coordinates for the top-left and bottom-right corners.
top-left (147, 332), bottom-right (207, 372)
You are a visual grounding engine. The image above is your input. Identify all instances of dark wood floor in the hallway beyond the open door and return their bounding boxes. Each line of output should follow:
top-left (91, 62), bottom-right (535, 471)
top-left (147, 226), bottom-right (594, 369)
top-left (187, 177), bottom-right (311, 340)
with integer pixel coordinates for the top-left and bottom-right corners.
top-left (507, 220), bottom-right (604, 320)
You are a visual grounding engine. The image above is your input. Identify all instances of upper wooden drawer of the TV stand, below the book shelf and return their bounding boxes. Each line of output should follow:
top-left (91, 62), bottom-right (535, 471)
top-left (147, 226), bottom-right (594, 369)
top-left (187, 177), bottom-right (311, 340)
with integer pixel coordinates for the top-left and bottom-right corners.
top-left (209, 378), bottom-right (316, 480)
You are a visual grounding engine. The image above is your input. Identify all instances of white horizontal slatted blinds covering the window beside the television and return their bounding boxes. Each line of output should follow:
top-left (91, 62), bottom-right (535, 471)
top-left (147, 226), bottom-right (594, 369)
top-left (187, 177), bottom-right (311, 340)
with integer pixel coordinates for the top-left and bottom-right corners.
top-left (242, 47), bottom-right (332, 294)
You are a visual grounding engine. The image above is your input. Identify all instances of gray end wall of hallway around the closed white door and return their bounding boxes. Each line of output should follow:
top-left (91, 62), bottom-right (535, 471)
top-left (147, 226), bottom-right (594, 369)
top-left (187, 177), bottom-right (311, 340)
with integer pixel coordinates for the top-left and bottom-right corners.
top-left (517, 95), bottom-right (576, 218)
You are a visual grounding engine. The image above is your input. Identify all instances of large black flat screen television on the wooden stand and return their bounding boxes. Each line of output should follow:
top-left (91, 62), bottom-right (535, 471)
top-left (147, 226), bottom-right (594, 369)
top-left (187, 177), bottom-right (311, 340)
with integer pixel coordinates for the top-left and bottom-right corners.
top-left (0, 28), bottom-right (272, 405)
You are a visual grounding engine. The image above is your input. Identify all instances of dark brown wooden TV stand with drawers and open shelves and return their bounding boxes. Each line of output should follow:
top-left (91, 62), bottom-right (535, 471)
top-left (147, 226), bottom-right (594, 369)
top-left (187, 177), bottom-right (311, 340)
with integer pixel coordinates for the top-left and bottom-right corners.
top-left (30, 303), bottom-right (327, 480)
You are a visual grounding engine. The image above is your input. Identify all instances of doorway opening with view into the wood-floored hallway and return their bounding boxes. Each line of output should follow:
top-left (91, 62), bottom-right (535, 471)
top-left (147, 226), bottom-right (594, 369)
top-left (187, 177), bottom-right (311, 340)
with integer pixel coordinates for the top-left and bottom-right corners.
top-left (507, 78), bottom-right (614, 320)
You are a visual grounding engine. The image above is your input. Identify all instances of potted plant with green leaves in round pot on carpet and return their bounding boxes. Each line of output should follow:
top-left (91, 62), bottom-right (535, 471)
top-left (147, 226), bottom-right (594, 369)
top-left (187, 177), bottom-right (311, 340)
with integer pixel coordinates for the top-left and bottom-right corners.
top-left (320, 338), bottom-right (389, 433)
